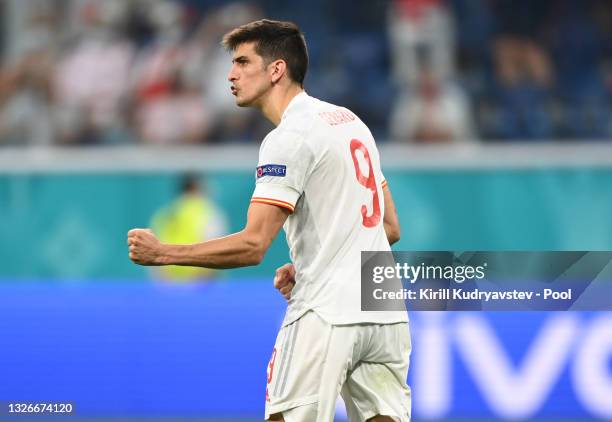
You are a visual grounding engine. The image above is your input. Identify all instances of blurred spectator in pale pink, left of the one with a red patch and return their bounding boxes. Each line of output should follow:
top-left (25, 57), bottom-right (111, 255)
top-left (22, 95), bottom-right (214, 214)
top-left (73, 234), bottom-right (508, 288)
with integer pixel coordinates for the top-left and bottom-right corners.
top-left (54, 0), bottom-right (135, 144)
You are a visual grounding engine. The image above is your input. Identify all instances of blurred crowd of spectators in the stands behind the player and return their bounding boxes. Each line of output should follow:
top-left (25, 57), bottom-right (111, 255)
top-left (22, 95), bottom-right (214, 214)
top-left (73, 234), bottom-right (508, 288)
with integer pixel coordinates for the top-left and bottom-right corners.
top-left (0, 0), bottom-right (612, 145)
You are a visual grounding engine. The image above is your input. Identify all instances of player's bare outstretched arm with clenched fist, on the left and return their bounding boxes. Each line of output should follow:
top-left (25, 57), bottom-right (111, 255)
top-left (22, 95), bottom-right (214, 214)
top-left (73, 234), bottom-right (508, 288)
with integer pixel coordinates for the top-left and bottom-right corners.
top-left (128, 203), bottom-right (289, 268)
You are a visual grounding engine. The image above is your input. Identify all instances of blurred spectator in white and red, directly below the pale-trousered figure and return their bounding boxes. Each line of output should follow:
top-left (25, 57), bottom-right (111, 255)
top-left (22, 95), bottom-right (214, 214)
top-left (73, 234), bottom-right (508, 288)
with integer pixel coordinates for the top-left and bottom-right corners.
top-left (391, 68), bottom-right (475, 143)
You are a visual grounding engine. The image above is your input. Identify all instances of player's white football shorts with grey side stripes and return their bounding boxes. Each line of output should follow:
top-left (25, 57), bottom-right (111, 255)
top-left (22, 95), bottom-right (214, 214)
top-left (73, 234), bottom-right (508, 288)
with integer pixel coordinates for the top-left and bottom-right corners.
top-left (266, 311), bottom-right (411, 422)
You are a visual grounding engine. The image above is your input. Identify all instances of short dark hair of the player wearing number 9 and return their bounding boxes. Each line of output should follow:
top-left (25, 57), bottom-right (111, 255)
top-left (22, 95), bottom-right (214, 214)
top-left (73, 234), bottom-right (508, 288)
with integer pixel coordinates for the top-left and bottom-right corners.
top-left (222, 19), bottom-right (308, 86)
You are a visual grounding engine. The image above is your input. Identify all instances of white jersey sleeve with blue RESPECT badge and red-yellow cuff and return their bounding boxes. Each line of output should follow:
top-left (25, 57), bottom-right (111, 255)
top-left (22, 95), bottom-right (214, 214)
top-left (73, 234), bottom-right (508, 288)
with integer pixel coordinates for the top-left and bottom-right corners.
top-left (251, 131), bottom-right (314, 213)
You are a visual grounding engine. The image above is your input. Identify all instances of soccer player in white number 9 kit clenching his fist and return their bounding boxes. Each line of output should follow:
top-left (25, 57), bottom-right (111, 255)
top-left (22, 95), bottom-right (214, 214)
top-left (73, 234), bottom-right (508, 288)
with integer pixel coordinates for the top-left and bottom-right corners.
top-left (128, 19), bottom-right (411, 422)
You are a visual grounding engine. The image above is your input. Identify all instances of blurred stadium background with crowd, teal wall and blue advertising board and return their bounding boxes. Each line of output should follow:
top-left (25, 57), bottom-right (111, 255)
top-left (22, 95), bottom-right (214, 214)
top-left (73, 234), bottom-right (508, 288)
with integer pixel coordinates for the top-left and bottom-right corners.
top-left (0, 0), bottom-right (612, 421)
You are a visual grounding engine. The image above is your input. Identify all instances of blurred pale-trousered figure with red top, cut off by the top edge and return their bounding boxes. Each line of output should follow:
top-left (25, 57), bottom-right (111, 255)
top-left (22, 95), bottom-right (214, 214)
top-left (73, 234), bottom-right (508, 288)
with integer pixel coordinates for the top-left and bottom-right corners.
top-left (388, 0), bottom-right (455, 86)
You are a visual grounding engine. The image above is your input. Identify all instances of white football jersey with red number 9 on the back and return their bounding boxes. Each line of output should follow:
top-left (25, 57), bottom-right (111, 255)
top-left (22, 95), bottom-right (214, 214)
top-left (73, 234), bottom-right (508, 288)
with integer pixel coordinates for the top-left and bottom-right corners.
top-left (251, 92), bottom-right (408, 325)
